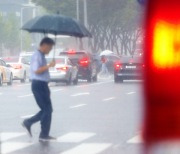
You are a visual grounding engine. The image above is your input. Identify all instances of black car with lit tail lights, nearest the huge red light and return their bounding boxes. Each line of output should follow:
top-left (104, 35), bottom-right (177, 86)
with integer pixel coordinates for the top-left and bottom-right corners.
top-left (114, 57), bottom-right (145, 83)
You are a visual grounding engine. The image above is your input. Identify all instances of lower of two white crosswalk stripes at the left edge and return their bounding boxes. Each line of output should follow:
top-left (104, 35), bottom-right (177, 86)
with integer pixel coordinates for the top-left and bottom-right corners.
top-left (1, 142), bottom-right (33, 154)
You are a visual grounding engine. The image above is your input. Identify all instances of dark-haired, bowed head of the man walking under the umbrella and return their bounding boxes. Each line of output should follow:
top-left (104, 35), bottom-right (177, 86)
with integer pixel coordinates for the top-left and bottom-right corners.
top-left (40, 37), bottom-right (55, 54)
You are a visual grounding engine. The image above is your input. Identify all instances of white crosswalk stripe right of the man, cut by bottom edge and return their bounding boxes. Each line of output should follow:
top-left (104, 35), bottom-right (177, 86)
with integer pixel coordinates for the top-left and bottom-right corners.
top-left (61, 143), bottom-right (112, 154)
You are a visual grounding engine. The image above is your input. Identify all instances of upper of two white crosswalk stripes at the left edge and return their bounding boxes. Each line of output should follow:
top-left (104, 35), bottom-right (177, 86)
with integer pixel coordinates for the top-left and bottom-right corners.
top-left (0, 132), bottom-right (26, 142)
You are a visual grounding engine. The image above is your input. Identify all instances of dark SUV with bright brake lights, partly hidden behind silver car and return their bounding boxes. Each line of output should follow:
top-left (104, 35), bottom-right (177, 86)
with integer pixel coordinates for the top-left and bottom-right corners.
top-left (59, 50), bottom-right (97, 82)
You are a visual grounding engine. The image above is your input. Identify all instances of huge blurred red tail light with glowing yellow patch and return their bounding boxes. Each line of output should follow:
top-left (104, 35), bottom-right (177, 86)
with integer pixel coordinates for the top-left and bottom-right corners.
top-left (144, 0), bottom-right (180, 146)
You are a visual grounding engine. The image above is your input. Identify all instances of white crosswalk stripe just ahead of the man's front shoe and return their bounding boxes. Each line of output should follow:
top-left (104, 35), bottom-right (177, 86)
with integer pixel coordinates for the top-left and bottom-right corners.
top-left (57, 132), bottom-right (96, 143)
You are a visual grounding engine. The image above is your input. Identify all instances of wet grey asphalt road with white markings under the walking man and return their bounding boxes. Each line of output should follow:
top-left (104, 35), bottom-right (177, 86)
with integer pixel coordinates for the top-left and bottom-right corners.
top-left (0, 79), bottom-right (142, 154)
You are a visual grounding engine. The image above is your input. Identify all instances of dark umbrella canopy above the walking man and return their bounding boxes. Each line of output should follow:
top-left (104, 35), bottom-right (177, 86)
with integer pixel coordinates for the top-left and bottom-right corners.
top-left (22, 15), bottom-right (92, 38)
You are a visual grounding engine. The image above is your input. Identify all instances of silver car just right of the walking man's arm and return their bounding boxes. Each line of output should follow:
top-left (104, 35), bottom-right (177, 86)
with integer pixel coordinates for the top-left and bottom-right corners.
top-left (46, 56), bottom-right (78, 85)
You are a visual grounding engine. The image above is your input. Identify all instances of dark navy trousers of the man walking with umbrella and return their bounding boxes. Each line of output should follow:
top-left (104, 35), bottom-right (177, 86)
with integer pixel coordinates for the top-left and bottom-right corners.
top-left (26, 80), bottom-right (53, 137)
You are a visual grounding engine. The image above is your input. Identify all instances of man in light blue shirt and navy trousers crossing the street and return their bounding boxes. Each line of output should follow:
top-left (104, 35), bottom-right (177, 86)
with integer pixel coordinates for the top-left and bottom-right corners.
top-left (22, 37), bottom-right (55, 141)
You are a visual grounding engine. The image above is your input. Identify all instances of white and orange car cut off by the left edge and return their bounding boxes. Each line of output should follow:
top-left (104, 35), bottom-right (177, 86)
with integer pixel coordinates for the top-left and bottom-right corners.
top-left (0, 59), bottom-right (13, 86)
